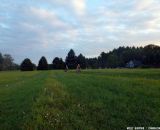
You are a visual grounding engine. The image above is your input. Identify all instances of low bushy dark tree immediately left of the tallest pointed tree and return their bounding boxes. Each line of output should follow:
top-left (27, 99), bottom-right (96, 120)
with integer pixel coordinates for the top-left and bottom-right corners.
top-left (52, 57), bottom-right (65, 69)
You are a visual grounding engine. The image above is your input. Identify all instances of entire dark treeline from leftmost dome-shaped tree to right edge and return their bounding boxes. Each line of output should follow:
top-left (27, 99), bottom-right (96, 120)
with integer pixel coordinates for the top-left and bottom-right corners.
top-left (21, 45), bottom-right (160, 71)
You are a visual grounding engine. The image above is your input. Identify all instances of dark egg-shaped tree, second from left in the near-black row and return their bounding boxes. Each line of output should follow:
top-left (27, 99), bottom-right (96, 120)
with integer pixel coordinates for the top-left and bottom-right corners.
top-left (37, 56), bottom-right (48, 70)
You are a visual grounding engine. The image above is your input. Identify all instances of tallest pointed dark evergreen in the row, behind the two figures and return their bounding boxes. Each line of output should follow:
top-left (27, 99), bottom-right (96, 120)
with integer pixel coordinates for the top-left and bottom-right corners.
top-left (66, 49), bottom-right (77, 69)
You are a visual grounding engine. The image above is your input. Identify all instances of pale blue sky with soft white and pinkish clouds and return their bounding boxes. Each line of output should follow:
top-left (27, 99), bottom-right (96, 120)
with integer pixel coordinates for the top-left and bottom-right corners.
top-left (0, 0), bottom-right (160, 64)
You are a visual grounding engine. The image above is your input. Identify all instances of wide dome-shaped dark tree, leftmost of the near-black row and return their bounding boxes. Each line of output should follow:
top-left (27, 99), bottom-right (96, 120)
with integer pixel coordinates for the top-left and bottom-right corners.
top-left (20, 58), bottom-right (34, 71)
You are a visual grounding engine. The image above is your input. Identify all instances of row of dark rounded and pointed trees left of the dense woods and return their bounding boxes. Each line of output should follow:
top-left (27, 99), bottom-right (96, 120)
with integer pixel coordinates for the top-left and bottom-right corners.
top-left (20, 49), bottom-right (87, 71)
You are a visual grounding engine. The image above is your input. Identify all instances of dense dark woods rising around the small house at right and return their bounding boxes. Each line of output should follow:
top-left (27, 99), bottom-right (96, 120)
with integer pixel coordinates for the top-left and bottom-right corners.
top-left (95, 45), bottom-right (160, 68)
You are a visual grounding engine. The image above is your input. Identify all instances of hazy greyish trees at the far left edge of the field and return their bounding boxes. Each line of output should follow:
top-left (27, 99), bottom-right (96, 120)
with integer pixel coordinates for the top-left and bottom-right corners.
top-left (0, 53), bottom-right (19, 71)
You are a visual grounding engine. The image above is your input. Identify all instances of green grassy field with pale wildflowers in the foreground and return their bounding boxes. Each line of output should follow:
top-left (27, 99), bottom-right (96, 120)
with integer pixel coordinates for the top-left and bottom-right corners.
top-left (0, 69), bottom-right (160, 130)
